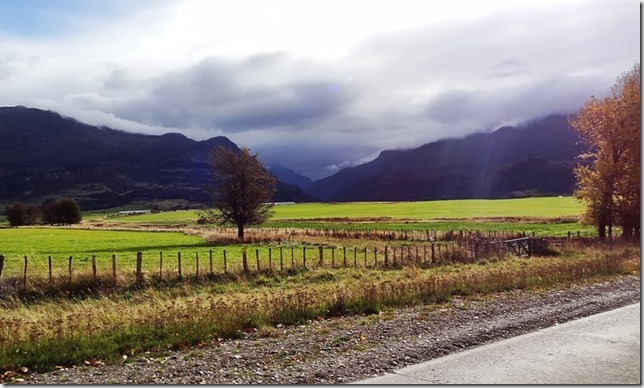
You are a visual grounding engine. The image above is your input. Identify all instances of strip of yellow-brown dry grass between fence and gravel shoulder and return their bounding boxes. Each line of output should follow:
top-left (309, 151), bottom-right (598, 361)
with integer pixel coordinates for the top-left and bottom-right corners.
top-left (0, 242), bottom-right (639, 370)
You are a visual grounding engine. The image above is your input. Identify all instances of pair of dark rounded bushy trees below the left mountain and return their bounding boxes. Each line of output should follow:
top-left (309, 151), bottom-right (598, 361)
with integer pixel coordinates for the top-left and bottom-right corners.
top-left (5, 197), bottom-right (83, 226)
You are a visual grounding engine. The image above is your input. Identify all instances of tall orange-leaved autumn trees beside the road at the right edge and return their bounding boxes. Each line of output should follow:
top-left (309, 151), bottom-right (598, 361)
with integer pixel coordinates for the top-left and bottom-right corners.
top-left (570, 64), bottom-right (641, 238)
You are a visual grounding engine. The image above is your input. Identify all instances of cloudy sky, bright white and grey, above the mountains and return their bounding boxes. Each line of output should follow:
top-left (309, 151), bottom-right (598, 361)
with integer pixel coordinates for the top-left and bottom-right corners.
top-left (0, 0), bottom-right (640, 179)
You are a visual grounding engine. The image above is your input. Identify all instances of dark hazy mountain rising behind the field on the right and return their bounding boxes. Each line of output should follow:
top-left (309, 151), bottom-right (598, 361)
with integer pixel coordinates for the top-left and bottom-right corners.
top-left (308, 115), bottom-right (582, 201)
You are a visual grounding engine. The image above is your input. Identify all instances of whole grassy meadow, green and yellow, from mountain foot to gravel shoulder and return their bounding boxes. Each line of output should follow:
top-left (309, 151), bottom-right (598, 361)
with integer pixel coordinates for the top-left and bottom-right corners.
top-left (0, 197), bottom-right (640, 375)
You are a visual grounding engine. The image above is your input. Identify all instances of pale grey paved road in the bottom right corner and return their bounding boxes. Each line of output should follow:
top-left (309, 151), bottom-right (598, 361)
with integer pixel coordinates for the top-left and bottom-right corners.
top-left (354, 303), bottom-right (641, 384)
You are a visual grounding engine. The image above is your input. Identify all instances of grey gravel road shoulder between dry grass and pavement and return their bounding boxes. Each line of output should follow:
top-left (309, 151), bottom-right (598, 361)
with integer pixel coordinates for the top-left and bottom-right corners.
top-left (20, 276), bottom-right (640, 384)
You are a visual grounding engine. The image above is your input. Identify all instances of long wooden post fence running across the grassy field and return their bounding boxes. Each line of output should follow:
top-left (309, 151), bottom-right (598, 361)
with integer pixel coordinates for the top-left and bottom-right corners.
top-left (0, 233), bottom-right (600, 293)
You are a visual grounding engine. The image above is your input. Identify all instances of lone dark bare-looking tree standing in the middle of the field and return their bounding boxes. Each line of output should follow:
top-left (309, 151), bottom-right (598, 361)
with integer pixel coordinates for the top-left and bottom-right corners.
top-left (209, 146), bottom-right (276, 240)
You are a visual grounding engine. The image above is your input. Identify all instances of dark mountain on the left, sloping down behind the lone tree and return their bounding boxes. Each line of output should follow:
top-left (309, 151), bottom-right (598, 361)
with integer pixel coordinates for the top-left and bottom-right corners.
top-left (0, 107), bottom-right (310, 210)
